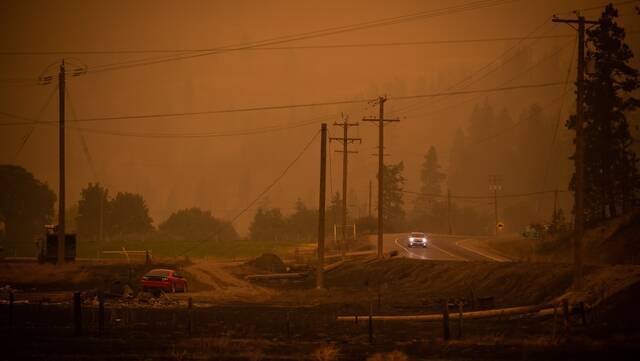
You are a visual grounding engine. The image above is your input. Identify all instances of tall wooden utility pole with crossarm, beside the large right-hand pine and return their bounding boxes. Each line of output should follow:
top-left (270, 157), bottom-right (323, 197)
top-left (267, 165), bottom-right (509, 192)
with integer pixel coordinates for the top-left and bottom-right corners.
top-left (551, 15), bottom-right (598, 290)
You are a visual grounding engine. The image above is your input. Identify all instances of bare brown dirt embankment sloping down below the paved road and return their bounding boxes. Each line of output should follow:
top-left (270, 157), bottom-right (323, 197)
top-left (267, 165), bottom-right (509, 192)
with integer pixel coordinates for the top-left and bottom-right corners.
top-left (292, 258), bottom-right (640, 310)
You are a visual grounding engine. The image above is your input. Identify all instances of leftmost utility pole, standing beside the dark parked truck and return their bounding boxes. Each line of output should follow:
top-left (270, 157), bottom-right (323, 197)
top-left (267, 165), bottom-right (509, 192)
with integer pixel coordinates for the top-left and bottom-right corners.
top-left (58, 60), bottom-right (66, 264)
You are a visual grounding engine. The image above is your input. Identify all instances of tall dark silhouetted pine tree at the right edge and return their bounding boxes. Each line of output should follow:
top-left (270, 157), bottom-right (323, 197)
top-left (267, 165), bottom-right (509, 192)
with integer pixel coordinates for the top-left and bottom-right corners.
top-left (567, 4), bottom-right (640, 224)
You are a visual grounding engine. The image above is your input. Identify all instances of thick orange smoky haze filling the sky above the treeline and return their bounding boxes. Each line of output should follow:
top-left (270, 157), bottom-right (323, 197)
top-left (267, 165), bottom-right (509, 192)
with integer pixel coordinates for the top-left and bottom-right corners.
top-left (0, 0), bottom-right (640, 233)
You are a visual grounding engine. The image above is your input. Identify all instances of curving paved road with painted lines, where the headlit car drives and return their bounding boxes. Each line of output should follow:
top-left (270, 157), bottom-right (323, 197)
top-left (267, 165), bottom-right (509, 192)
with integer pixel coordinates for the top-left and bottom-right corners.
top-left (383, 234), bottom-right (509, 262)
